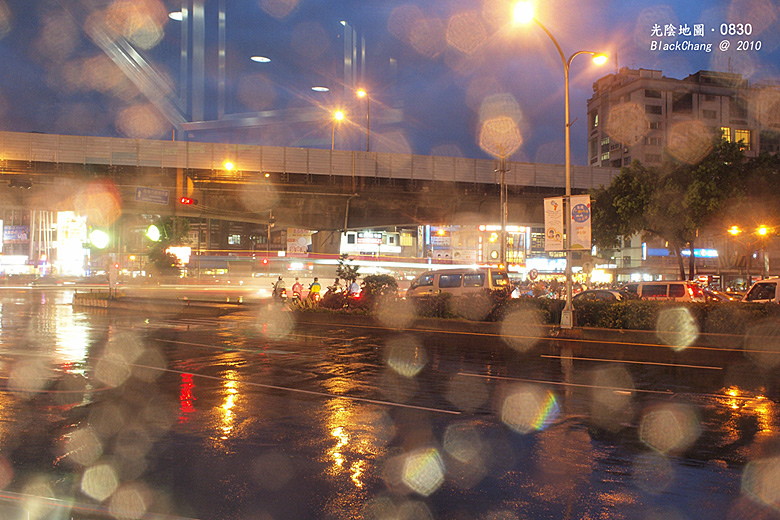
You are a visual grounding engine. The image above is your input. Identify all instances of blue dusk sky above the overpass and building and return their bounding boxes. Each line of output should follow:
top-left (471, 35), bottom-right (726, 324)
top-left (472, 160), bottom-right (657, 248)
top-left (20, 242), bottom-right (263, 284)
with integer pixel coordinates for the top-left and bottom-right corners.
top-left (0, 0), bottom-right (780, 164)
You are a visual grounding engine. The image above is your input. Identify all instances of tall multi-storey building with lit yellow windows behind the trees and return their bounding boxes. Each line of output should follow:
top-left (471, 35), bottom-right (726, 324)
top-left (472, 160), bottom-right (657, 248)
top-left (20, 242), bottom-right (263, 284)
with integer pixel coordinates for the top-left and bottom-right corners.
top-left (588, 67), bottom-right (780, 167)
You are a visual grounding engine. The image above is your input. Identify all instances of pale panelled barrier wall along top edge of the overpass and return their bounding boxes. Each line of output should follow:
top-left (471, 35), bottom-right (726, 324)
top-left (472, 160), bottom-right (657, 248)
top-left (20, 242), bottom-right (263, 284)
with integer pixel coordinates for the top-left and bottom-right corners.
top-left (0, 132), bottom-right (620, 189)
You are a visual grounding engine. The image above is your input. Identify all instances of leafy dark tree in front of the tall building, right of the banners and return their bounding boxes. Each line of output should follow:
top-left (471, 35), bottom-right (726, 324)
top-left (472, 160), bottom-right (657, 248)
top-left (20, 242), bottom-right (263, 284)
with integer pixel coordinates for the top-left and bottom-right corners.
top-left (592, 139), bottom-right (745, 280)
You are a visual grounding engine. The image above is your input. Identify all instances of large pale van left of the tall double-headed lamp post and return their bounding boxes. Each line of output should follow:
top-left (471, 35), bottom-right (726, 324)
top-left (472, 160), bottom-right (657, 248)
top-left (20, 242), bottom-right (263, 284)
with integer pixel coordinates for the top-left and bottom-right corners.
top-left (406, 267), bottom-right (512, 298)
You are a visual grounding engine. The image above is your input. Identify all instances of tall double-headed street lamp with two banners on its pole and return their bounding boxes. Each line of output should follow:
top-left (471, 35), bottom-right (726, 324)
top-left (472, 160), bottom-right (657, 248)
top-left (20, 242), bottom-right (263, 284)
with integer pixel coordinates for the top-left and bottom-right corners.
top-left (513, 2), bottom-right (607, 329)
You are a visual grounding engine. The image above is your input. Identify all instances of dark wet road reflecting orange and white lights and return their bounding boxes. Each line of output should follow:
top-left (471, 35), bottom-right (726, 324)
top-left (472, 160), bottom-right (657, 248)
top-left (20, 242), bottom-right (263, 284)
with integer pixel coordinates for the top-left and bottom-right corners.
top-left (0, 289), bottom-right (780, 520)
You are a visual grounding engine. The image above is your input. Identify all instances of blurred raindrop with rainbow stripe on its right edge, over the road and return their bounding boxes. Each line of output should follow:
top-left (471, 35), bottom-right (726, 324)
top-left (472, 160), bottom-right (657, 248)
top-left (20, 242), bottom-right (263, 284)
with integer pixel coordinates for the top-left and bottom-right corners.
top-left (500, 384), bottom-right (560, 433)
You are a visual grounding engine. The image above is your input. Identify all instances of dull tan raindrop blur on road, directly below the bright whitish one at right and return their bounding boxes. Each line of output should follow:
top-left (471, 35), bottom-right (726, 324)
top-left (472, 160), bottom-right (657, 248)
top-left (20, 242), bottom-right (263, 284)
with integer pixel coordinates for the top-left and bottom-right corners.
top-left (639, 403), bottom-right (701, 454)
